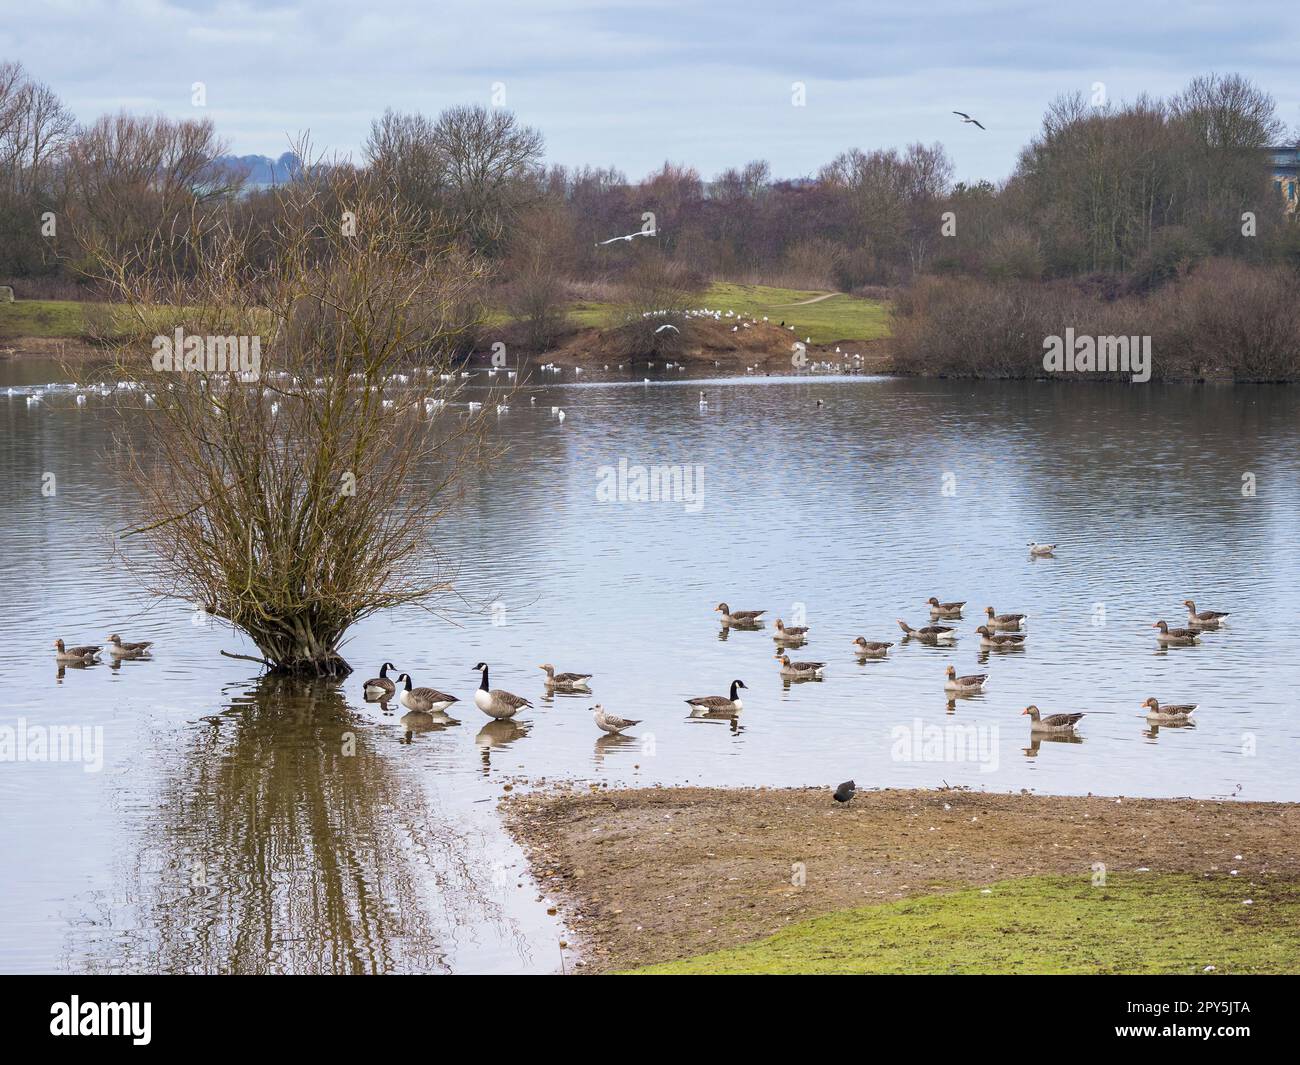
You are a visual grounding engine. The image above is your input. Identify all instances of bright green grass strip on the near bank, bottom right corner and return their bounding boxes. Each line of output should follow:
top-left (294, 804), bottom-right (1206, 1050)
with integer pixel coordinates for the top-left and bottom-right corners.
top-left (636, 874), bottom-right (1300, 974)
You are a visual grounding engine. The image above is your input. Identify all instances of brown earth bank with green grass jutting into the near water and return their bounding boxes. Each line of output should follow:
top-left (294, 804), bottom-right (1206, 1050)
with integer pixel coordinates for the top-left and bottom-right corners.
top-left (503, 787), bottom-right (1300, 971)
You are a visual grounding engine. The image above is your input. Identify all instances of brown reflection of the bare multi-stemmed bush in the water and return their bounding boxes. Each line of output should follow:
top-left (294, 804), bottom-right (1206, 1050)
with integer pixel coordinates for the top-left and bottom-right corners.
top-left (68, 676), bottom-right (510, 974)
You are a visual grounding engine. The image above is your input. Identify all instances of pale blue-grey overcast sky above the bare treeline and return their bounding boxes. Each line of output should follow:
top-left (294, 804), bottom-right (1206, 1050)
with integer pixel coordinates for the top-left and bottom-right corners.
top-left (0, 0), bottom-right (1300, 181)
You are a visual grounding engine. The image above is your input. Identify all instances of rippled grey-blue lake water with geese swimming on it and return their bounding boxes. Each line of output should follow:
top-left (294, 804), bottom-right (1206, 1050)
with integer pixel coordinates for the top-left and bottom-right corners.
top-left (0, 362), bottom-right (1300, 973)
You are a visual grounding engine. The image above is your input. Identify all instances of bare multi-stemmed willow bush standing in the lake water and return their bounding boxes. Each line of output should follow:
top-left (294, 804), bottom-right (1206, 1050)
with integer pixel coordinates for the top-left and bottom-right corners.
top-left (74, 161), bottom-right (490, 675)
